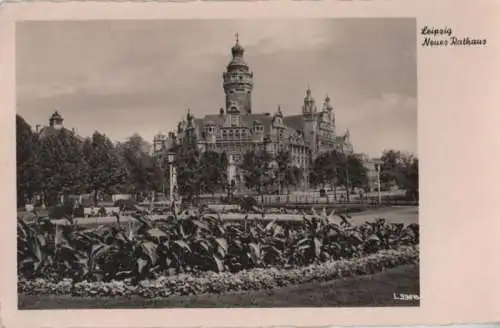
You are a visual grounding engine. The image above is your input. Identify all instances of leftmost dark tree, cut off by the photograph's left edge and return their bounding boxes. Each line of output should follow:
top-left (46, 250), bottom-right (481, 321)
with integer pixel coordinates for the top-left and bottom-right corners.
top-left (16, 115), bottom-right (41, 206)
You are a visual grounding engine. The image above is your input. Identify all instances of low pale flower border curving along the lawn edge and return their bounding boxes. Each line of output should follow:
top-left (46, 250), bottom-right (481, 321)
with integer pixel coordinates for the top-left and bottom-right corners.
top-left (18, 246), bottom-right (419, 298)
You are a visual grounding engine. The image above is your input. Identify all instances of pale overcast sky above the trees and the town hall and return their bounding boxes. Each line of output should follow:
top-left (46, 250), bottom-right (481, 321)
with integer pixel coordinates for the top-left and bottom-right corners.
top-left (16, 18), bottom-right (417, 156)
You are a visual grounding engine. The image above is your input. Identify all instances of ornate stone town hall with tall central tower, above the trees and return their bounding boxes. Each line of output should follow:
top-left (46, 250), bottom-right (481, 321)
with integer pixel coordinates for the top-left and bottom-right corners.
top-left (153, 37), bottom-right (353, 188)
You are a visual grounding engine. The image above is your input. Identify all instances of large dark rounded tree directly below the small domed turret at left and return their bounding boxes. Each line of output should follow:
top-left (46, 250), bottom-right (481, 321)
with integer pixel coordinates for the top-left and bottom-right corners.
top-left (38, 129), bottom-right (88, 205)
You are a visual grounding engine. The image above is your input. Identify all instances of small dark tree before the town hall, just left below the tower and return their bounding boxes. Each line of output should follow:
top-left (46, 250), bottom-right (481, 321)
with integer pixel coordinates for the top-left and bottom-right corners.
top-left (199, 151), bottom-right (229, 194)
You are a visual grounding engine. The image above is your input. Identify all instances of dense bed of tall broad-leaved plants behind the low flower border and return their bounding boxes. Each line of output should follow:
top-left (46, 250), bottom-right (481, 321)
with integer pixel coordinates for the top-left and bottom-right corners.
top-left (17, 208), bottom-right (419, 285)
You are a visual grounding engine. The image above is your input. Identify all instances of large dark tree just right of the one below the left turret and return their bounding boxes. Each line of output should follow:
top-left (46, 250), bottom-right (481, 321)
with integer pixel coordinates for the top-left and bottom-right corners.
top-left (83, 131), bottom-right (128, 200)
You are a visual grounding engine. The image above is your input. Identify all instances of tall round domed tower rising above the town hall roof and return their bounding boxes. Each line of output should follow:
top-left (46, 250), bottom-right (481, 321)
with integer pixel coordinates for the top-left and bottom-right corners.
top-left (222, 33), bottom-right (253, 115)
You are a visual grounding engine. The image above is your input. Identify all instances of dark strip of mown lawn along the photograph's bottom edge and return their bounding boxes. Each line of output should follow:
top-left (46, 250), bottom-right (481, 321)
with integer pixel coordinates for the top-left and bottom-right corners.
top-left (18, 265), bottom-right (420, 310)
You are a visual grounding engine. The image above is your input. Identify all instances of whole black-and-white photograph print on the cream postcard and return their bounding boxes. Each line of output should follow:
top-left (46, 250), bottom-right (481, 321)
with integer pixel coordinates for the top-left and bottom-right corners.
top-left (15, 17), bottom-right (420, 310)
